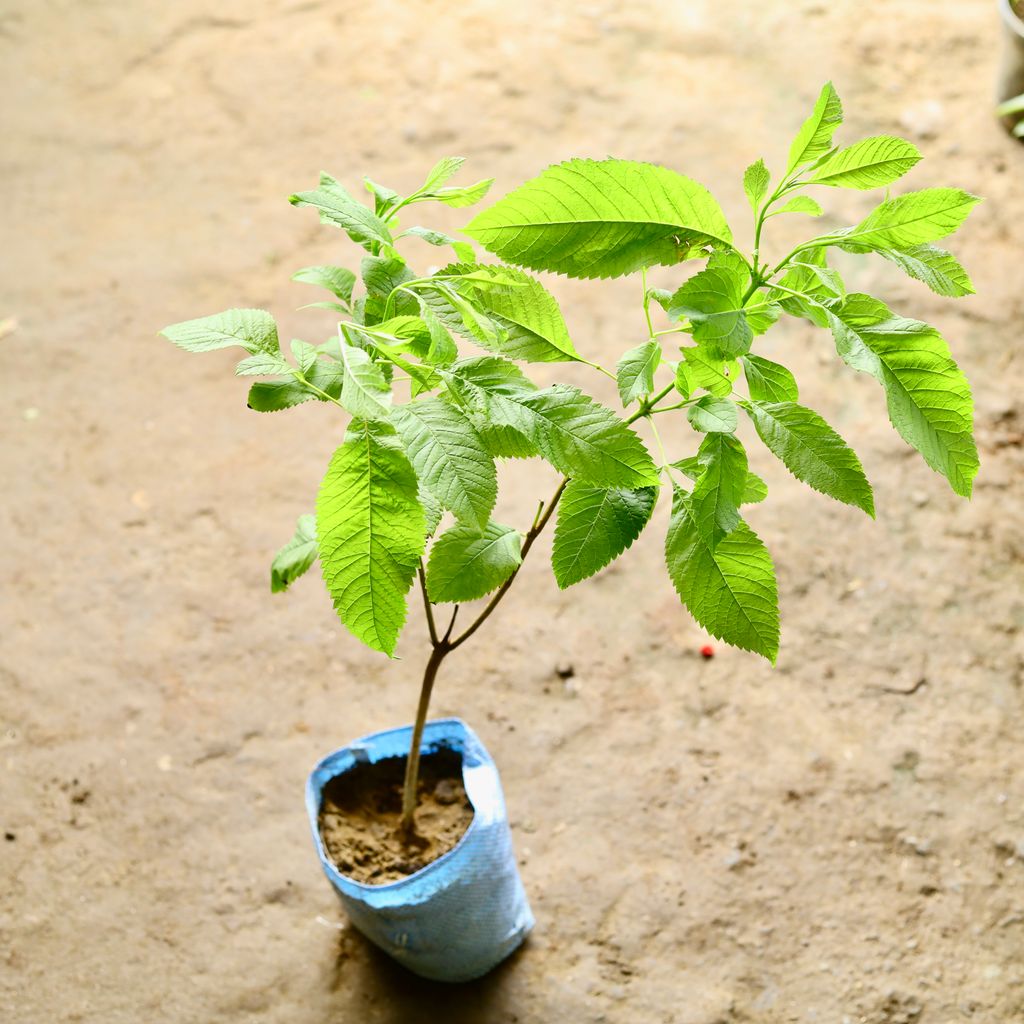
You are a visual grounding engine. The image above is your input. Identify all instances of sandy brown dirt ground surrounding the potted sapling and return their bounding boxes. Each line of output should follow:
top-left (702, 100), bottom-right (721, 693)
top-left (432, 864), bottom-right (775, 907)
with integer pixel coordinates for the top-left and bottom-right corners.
top-left (0, 0), bottom-right (1024, 1024)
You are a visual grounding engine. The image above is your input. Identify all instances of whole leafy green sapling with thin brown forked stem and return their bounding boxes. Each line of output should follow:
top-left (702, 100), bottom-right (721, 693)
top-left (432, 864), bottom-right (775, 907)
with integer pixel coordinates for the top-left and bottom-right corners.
top-left (163, 84), bottom-right (978, 842)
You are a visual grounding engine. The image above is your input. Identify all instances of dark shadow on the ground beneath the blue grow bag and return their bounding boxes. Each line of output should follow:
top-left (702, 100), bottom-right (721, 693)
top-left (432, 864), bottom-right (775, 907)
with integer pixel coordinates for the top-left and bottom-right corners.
top-left (331, 928), bottom-right (529, 1024)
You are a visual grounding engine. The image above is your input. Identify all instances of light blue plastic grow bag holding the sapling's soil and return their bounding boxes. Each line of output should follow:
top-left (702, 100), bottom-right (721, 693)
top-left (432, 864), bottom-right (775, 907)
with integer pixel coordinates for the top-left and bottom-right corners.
top-left (306, 718), bottom-right (534, 981)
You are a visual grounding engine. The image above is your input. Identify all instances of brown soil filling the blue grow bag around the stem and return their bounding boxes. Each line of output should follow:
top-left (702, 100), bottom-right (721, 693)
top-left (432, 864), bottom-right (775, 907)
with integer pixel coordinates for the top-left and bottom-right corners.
top-left (319, 751), bottom-right (473, 885)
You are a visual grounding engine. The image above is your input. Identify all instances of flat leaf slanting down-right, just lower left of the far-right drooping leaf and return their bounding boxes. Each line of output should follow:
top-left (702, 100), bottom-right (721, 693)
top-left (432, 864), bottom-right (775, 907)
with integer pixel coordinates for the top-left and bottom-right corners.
top-left (743, 401), bottom-right (874, 518)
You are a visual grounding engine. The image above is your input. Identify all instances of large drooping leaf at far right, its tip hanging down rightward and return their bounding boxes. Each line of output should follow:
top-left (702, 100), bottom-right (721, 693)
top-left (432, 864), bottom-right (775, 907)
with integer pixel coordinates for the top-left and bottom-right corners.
top-left (833, 295), bottom-right (978, 497)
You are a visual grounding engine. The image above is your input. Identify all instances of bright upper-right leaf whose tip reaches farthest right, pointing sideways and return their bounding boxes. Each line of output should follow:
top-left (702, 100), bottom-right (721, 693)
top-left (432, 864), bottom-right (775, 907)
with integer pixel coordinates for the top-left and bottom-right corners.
top-left (829, 188), bottom-right (981, 252)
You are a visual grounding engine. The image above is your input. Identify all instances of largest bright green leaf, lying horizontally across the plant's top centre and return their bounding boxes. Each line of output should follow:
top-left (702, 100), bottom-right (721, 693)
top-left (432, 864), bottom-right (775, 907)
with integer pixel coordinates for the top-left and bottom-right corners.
top-left (465, 160), bottom-right (732, 278)
